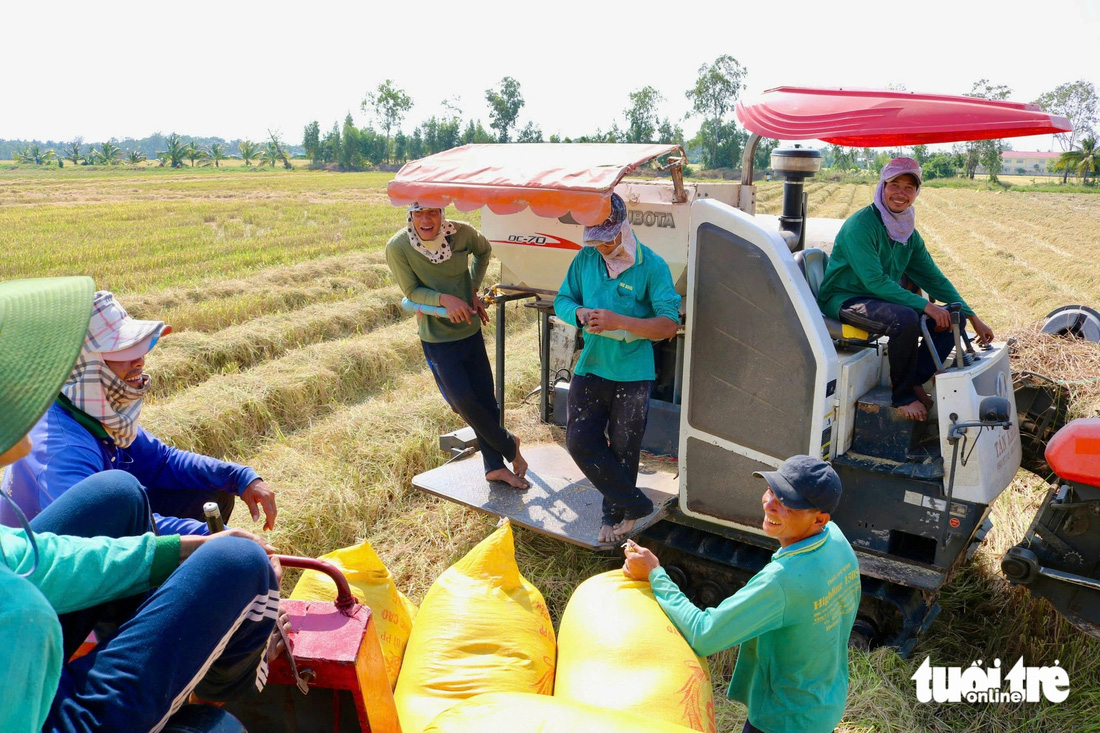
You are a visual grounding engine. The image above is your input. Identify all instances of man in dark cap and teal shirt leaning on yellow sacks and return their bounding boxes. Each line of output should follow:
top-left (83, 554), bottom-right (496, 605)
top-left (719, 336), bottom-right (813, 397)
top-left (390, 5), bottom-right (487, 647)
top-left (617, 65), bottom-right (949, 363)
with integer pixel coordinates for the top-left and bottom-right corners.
top-left (623, 456), bottom-right (860, 733)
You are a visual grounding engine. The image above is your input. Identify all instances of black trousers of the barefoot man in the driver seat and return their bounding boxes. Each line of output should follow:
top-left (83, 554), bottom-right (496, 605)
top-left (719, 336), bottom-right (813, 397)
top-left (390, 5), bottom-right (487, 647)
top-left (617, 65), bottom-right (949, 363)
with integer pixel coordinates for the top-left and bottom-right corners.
top-left (840, 298), bottom-right (955, 407)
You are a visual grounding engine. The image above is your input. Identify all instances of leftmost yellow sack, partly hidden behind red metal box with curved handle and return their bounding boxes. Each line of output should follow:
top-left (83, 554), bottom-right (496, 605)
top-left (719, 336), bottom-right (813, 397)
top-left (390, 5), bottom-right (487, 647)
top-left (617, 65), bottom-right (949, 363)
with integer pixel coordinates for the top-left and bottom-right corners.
top-left (290, 543), bottom-right (416, 689)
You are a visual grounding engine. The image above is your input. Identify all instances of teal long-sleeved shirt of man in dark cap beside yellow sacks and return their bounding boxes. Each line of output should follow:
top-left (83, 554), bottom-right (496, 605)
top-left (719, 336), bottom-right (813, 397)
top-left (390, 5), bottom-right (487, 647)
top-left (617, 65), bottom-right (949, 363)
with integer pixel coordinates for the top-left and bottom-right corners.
top-left (649, 522), bottom-right (860, 733)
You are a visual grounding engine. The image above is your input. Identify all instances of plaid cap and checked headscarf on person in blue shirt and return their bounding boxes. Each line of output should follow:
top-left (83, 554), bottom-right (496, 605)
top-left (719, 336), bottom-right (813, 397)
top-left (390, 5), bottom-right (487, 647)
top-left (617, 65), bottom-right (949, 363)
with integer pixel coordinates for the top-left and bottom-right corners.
top-left (62, 291), bottom-right (172, 448)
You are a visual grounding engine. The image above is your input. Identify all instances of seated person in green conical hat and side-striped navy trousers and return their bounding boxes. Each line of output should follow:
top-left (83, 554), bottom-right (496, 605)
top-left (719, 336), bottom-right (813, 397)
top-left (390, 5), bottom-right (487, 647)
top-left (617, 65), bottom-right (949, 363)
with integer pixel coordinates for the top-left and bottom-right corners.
top-left (0, 277), bottom-right (286, 733)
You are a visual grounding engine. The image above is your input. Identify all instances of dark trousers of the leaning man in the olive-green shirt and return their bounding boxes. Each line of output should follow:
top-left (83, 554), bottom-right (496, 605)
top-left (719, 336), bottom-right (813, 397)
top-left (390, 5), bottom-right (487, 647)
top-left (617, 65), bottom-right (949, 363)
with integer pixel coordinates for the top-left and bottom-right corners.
top-left (420, 330), bottom-right (516, 473)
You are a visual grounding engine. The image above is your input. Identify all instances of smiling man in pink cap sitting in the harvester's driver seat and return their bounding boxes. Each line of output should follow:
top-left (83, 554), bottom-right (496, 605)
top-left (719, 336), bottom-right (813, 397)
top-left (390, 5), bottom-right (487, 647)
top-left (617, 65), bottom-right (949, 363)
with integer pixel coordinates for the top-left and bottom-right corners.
top-left (817, 157), bottom-right (993, 420)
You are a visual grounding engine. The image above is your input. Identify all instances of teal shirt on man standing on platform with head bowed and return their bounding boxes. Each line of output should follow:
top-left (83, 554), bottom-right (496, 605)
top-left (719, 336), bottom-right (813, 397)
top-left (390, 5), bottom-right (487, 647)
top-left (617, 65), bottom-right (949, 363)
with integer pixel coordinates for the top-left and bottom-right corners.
top-left (553, 242), bottom-right (680, 382)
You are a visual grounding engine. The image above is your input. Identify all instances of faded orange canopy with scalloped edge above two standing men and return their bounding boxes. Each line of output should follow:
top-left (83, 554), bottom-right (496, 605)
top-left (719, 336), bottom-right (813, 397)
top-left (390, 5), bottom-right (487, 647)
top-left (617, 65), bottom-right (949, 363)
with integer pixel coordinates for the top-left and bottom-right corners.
top-left (388, 143), bottom-right (680, 226)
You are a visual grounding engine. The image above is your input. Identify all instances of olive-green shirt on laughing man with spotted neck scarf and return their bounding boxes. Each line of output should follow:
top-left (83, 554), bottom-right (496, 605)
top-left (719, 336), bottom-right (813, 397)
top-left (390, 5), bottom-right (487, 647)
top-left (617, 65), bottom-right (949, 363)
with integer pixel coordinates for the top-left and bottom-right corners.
top-left (386, 221), bottom-right (493, 343)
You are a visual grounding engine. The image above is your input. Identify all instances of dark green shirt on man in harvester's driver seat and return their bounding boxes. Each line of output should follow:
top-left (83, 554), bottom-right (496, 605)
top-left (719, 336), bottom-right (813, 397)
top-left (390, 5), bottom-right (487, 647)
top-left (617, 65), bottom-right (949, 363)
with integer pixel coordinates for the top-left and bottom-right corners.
top-left (817, 204), bottom-right (974, 318)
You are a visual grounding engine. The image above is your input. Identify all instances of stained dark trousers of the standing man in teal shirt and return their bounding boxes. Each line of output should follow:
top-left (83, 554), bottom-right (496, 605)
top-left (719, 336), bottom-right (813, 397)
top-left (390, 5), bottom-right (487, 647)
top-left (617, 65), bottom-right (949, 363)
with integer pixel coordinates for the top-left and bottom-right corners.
top-left (565, 374), bottom-right (653, 525)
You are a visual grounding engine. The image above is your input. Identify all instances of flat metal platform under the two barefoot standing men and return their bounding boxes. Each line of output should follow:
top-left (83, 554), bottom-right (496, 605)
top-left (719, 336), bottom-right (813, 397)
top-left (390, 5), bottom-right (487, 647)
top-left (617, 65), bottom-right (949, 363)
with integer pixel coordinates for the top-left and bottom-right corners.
top-left (413, 444), bottom-right (679, 549)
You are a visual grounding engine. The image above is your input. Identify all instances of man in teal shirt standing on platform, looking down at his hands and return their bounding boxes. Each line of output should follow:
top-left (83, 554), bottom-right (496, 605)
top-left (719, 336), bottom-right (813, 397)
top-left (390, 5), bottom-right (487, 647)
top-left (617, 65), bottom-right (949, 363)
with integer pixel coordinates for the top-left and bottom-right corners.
top-left (553, 194), bottom-right (680, 543)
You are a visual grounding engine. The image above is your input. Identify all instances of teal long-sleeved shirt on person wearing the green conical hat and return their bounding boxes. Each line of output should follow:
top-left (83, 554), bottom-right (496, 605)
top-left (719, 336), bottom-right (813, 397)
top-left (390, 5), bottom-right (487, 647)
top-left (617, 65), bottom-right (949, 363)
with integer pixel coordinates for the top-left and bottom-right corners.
top-left (0, 527), bottom-right (179, 733)
